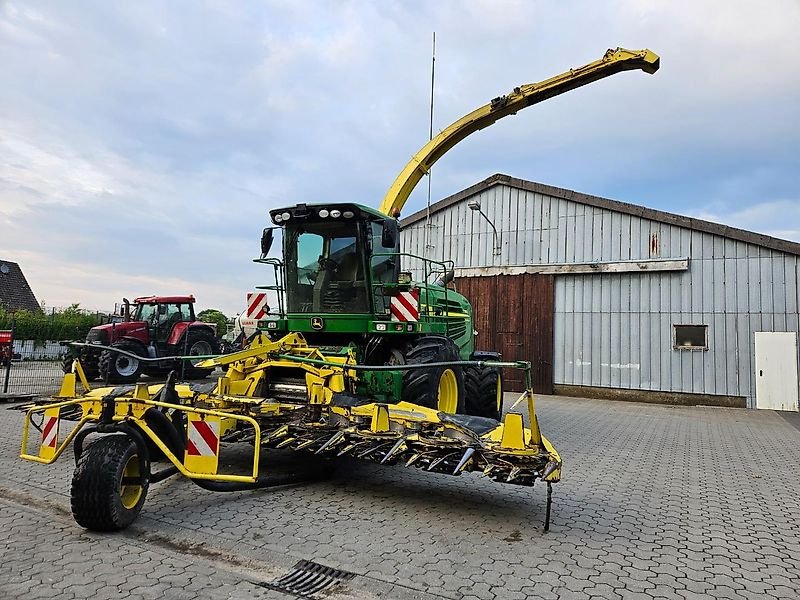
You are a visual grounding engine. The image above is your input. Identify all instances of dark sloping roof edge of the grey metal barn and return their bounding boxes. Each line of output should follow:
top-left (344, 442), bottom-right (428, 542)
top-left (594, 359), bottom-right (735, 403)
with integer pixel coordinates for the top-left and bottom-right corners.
top-left (400, 173), bottom-right (800, 256)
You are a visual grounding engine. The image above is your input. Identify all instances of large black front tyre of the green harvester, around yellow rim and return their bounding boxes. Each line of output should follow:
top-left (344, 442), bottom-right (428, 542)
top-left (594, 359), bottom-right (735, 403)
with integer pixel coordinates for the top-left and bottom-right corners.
top-left (402, 335), bottom-right (464, 414)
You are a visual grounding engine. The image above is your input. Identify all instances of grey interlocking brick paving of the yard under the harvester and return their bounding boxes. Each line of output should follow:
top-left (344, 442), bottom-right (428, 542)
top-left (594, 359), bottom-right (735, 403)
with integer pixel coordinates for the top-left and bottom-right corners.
top-left (0, 398), bottom-right (800, 600)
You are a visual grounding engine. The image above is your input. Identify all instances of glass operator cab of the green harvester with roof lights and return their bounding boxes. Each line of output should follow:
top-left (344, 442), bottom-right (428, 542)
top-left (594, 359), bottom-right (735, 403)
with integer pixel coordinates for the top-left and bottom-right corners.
top-left (270, 204), bottom-right (400, 314)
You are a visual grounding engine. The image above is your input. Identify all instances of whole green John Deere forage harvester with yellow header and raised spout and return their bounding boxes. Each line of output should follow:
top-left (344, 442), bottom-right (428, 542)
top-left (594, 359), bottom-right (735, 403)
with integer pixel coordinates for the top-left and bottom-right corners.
top-left (21, 49), bottom-right (659, 530)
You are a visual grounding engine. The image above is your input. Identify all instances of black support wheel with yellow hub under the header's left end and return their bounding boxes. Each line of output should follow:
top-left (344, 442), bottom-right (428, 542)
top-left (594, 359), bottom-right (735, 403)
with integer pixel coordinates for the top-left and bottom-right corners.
top-left (70, 435), bottom-right (150, 531)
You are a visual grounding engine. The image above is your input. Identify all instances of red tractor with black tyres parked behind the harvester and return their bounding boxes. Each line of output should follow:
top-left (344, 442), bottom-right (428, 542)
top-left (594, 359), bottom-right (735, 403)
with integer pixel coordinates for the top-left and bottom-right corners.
top-left (63, 296), bottom-right (220, 383)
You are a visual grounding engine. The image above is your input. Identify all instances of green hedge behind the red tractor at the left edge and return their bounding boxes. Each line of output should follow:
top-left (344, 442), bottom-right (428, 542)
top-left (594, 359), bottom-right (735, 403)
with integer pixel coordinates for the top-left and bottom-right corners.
top-left (0, 304), bottom-right (108, 343)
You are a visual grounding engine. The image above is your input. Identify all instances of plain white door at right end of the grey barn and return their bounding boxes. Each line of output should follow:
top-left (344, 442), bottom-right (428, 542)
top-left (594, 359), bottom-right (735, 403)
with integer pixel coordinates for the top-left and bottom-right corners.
top-left (755, 331), bottom-right (797, 411)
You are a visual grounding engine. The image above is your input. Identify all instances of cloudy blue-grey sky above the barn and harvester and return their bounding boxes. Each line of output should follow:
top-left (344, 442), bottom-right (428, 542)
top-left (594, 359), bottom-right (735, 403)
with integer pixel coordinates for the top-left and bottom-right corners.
top-left (0, 0), bottom-right (800, 314)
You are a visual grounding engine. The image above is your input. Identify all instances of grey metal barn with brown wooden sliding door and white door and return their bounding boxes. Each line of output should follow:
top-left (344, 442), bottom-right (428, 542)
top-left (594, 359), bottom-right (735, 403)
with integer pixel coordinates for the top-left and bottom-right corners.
top-left (401, 175), bottom-right (800, 410)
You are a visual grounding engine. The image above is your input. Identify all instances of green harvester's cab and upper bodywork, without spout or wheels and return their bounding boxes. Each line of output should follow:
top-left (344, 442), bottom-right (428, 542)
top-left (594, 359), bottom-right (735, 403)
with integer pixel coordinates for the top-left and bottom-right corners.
top-left (256, 203), bottom-right (473, 357)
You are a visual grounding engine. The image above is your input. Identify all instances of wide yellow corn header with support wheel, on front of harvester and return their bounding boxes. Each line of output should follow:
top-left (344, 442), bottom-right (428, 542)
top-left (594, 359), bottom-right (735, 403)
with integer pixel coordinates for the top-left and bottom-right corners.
top-left (20, 334), bottom-right (561, 530)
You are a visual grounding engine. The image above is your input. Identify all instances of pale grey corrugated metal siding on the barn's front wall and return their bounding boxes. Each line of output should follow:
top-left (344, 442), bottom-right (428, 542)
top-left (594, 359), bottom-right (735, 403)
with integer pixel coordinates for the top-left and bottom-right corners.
top-left (402, 185), bottom-right (800, 406)
